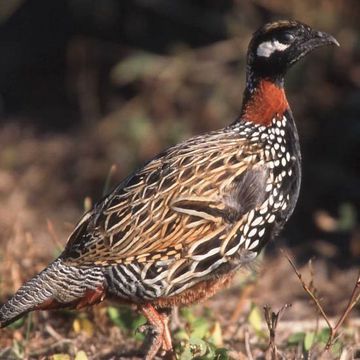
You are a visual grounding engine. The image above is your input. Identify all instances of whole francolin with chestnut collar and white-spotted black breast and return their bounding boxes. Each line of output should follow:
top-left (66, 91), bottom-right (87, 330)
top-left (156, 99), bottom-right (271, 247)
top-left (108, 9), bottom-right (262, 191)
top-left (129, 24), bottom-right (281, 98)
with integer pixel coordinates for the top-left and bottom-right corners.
top-left (0, 20), bottom-right (339, 360)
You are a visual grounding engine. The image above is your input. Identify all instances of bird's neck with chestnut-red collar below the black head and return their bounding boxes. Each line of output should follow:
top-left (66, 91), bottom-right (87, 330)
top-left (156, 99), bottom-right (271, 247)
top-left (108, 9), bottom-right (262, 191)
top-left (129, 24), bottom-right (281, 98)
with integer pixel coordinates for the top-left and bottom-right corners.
top-left (240, 75), bottom-right (289, 126)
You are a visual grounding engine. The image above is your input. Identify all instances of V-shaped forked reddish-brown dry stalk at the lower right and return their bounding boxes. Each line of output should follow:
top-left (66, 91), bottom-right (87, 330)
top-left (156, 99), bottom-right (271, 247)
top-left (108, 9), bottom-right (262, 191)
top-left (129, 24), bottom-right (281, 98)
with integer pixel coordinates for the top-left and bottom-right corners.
top-left (281, 250), bottom-right (360, 351)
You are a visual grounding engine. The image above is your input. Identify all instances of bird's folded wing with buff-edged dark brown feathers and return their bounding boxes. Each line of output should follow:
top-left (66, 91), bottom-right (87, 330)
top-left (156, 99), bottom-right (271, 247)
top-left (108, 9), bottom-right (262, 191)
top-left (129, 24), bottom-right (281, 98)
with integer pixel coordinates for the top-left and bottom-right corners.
top-left (62, 132), bottom-right (266, 266)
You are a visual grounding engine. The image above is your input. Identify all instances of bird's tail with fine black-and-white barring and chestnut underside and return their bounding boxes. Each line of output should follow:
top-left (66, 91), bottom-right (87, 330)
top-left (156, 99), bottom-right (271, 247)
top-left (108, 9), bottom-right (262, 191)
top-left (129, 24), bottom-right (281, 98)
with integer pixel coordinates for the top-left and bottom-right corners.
top-left (0, 259), bottom-right (106, 328)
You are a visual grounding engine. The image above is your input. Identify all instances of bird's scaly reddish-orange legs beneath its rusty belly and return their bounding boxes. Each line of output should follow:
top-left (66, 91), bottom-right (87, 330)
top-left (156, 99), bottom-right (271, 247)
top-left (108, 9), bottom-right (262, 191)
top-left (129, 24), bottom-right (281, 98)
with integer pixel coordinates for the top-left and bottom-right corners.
top-left (139, 304), bottom-right (172, 360)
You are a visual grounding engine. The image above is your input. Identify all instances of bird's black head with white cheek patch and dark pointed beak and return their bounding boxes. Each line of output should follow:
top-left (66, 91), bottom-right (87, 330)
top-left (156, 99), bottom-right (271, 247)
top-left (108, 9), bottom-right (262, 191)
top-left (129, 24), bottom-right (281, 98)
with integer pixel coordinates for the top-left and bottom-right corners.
top-left (247, 20), bottom-right (339, 88)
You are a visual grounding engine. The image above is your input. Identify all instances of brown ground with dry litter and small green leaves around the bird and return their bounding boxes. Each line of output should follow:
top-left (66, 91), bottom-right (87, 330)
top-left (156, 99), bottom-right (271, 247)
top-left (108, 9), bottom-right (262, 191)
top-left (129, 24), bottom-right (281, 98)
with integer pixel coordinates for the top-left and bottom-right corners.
top-left (0, 121), bottom-right (360, 360)
